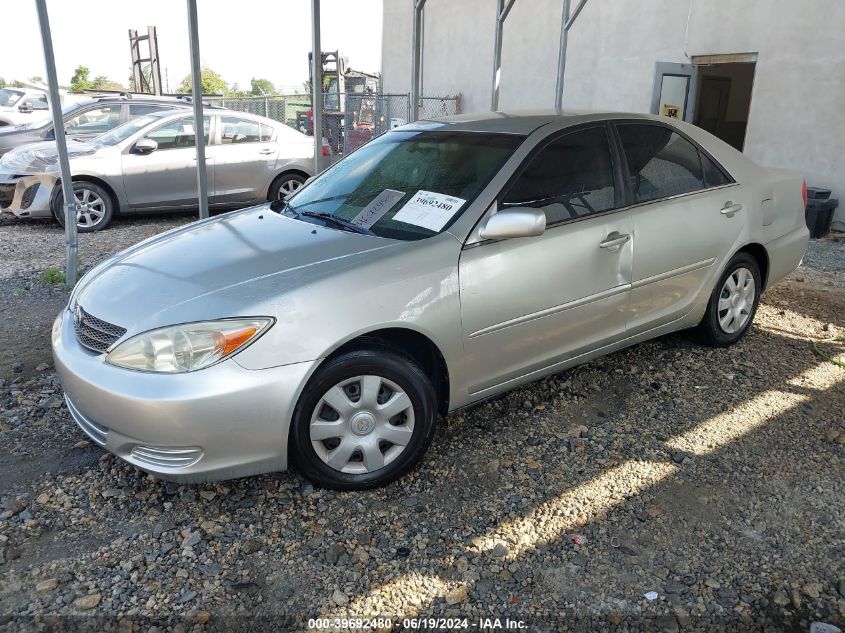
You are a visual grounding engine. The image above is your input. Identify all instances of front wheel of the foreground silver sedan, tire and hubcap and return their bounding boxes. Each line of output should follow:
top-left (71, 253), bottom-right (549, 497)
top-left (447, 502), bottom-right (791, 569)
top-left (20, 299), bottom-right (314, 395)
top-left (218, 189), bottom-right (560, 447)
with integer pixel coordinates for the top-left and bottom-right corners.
top-left (289, 350), bottom-right (437, 490)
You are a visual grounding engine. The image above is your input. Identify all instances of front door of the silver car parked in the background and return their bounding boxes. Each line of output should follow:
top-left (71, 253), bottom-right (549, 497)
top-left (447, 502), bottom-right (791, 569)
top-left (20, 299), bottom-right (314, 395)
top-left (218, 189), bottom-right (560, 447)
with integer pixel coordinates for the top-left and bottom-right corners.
top-left (122, 116), bottom-right (214, 209)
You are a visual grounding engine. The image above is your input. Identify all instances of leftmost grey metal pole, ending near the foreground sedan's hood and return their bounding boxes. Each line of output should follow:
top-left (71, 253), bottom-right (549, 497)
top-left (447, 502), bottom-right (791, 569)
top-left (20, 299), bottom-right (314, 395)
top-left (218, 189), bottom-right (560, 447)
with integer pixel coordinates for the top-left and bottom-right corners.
top-left (35, 0), bottom-right (80, 288)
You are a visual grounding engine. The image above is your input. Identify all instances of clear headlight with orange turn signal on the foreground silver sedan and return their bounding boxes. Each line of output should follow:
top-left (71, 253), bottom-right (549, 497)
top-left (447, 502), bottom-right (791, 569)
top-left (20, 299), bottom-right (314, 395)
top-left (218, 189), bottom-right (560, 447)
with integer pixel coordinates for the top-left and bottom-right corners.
top-left (106, 317), bottom-right (274, 374)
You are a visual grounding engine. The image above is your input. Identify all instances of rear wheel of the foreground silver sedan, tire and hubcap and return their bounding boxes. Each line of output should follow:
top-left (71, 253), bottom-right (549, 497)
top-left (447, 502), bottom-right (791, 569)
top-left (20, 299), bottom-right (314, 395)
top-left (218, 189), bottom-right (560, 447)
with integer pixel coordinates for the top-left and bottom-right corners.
top-left (696, 252), bottom-right (763, 347)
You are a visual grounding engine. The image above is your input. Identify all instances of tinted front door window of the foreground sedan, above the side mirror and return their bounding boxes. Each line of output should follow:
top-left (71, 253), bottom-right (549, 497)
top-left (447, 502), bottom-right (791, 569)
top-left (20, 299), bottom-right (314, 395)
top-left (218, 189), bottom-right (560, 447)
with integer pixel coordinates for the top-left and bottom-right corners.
top-left (502, 127), bottom-right (616, 224)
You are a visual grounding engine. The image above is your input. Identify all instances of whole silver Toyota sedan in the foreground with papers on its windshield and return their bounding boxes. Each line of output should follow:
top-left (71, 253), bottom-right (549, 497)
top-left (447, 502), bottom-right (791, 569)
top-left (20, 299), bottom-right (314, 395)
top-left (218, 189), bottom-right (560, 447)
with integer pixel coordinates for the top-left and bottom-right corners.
top-left (53, 114), bottom-right (808, 489)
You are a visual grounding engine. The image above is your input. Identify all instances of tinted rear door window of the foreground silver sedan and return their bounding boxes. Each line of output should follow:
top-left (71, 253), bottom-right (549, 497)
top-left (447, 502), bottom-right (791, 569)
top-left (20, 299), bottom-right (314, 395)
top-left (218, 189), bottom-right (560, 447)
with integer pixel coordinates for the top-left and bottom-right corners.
top-left (618, 124), bottom-right (705, 202)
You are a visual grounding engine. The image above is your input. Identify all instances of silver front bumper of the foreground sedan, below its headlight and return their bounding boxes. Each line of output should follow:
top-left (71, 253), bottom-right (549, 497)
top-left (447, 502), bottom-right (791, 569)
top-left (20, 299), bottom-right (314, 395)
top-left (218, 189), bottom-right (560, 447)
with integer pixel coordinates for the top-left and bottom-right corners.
top-left (53, 309), bottom-right (317, 482)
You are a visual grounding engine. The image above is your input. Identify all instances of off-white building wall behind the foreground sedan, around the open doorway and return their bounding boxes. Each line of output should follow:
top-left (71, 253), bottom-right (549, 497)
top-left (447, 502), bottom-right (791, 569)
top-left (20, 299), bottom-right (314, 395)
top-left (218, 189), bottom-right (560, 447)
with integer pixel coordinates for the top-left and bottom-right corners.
top-left (382, 0), bottom-right (845, 226)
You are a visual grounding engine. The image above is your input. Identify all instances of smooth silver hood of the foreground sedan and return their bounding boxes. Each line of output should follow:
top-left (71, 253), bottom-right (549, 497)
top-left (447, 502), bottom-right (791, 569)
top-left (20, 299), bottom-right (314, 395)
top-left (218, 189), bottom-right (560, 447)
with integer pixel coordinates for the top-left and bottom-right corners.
top-left (73, 206), bottom-right (404, 334)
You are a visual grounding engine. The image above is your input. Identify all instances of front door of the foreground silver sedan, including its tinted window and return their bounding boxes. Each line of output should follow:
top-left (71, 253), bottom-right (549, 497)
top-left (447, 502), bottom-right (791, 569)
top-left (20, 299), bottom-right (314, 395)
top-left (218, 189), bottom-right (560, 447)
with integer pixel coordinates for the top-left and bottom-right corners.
top-left (459, 124), bottom-right (633, 396)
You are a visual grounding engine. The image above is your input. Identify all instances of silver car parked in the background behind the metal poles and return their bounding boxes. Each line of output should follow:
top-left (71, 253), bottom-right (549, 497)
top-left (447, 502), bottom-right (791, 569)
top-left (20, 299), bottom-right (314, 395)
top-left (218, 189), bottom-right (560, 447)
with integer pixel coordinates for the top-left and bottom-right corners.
top-left (0, 106), bottom-right (314, 232)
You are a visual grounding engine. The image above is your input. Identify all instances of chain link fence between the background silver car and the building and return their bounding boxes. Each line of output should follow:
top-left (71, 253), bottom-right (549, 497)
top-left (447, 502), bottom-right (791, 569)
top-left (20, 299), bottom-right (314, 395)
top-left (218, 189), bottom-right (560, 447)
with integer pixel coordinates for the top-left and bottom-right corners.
top-left (206, 92), bottom-right (461, 156)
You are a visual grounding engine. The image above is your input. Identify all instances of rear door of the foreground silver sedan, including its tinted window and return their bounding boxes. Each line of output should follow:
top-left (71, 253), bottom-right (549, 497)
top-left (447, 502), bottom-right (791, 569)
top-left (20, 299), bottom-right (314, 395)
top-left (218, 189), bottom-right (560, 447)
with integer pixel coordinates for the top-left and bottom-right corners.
top-left (615, 121), bottom-right (749, 334)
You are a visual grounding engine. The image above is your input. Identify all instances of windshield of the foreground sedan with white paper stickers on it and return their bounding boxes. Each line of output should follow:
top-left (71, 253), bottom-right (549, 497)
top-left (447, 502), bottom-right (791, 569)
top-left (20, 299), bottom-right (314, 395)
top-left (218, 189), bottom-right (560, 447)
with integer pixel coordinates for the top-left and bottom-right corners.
top-left (287, 131), bottom-right (523, 240)
